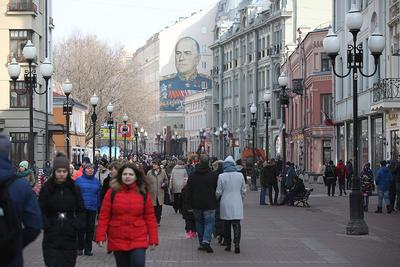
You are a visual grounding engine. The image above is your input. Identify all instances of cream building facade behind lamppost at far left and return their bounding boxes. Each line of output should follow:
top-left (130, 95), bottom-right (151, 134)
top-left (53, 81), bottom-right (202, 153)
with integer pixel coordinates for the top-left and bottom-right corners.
top-left (0, 0), bottom-right (54, 167)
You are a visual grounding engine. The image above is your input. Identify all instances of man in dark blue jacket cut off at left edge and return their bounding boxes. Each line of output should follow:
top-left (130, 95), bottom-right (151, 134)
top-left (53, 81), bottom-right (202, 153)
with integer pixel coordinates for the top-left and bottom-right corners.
top-left (0, 134), bottom-right (43, 267)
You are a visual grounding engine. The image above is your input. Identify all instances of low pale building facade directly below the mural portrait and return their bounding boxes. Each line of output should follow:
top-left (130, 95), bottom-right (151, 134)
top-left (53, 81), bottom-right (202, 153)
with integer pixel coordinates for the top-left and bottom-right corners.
top-left (184, 91), bottom-right (214, 155)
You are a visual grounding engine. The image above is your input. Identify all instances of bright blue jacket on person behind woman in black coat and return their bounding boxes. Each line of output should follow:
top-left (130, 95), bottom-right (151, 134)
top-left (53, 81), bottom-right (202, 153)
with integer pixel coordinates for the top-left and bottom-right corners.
top-left (75, 172), bottom-right (101, 211)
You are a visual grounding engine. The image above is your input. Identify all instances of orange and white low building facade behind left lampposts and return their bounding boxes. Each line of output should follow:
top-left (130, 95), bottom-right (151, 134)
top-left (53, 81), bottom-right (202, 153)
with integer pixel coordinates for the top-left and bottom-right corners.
top-left (53, 92), bottom-right (88, 164)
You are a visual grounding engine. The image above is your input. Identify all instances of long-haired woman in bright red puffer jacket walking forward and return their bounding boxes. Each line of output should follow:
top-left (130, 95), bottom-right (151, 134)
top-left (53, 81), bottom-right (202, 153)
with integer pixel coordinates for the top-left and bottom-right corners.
top-left (96, 163), bottom-right (158, 267)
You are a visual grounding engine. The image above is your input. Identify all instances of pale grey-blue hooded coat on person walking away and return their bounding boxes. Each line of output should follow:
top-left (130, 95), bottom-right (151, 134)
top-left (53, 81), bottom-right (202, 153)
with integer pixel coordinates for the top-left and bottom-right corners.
top-left (216, 156), bottom-right (246, 220)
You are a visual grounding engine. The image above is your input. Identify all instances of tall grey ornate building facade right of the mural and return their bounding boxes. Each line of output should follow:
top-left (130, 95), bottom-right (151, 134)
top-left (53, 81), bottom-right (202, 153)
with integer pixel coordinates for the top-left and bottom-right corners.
top-left (211, 0), bottom-right (332, 157)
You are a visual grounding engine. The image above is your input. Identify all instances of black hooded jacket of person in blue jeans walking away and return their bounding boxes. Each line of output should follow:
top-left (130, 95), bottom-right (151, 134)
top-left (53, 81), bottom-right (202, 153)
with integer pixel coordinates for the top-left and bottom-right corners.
top-left (185, 162), bottom-right (218, 210)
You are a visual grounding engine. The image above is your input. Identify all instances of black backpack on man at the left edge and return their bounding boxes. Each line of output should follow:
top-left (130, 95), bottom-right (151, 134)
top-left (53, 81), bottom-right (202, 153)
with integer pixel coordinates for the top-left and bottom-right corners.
top-left (0, 177), bottom-right (21, 265)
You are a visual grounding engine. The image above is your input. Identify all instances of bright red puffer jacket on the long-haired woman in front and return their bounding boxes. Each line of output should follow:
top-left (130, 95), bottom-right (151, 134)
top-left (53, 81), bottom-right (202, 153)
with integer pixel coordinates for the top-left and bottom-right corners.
top-left (96, 184), bottom-right (158, 251)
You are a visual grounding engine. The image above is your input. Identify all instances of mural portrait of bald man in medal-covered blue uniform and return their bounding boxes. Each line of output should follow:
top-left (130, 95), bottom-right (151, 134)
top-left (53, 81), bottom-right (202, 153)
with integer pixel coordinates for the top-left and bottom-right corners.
top-left (160, 37), bottom-right (212, 111)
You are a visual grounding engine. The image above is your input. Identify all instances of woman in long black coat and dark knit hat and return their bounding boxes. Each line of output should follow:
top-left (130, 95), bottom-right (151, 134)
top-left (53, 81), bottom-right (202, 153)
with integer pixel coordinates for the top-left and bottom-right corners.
top-left (39, 154), bottom-right (85, 267)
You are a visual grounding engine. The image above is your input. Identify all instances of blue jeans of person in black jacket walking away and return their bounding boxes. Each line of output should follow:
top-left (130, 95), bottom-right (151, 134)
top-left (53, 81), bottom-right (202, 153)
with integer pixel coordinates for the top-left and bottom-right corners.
top-left (194, 209), bottom-right (215, 245)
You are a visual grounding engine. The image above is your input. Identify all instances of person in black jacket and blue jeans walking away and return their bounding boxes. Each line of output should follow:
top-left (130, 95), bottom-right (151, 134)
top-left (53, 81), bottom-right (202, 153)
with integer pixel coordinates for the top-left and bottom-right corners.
top-left (185, 155), bottom-right (218, 253)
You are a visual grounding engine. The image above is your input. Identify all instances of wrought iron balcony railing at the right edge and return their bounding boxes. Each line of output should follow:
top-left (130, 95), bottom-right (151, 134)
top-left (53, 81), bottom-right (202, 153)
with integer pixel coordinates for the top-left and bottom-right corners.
top-left (372, 78), bottom-right (400, 102)
